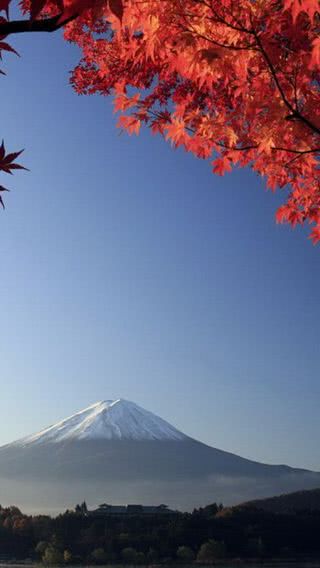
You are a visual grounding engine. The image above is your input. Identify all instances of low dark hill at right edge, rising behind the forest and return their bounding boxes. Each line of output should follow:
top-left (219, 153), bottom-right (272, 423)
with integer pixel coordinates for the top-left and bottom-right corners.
top-left (239, 488), bottom-right (320, 513)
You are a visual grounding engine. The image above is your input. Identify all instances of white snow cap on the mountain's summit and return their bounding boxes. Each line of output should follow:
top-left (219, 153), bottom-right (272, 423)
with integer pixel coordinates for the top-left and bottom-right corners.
top-left (13, 399), bottom-right (187, 446)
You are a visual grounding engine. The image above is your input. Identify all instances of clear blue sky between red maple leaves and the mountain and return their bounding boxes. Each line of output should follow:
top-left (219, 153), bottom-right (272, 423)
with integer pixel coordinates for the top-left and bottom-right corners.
top-left (0, 23), bottom-right (320, 470)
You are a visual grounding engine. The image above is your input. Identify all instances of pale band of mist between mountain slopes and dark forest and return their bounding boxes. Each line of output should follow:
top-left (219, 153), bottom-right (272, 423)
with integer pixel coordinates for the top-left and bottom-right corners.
top-left (0, 470), bottom-right (319, 514)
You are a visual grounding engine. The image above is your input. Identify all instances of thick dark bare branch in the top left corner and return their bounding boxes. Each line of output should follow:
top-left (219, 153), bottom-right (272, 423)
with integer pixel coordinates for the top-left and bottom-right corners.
top-left (0, 14), bottom-right (78, 36)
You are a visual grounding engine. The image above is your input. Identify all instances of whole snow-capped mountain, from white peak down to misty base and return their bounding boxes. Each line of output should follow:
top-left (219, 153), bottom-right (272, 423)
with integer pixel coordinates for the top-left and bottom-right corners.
top-left (0, 399), bottom-right (320, 512)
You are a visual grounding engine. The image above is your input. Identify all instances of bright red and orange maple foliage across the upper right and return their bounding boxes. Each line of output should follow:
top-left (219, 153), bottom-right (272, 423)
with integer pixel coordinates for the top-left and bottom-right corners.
top-left (0, 0), bottom-right (320, 242)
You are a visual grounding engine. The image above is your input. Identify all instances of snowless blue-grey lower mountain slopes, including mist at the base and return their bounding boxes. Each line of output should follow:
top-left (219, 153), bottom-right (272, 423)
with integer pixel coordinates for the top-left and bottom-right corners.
top-left (0, 439), bottom-right (320, 514)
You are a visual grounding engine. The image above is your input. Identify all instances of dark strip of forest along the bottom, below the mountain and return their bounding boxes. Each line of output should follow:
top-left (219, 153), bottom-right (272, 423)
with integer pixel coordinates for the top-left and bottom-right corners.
top-left (0, 504), bottom-right (320, 565)
